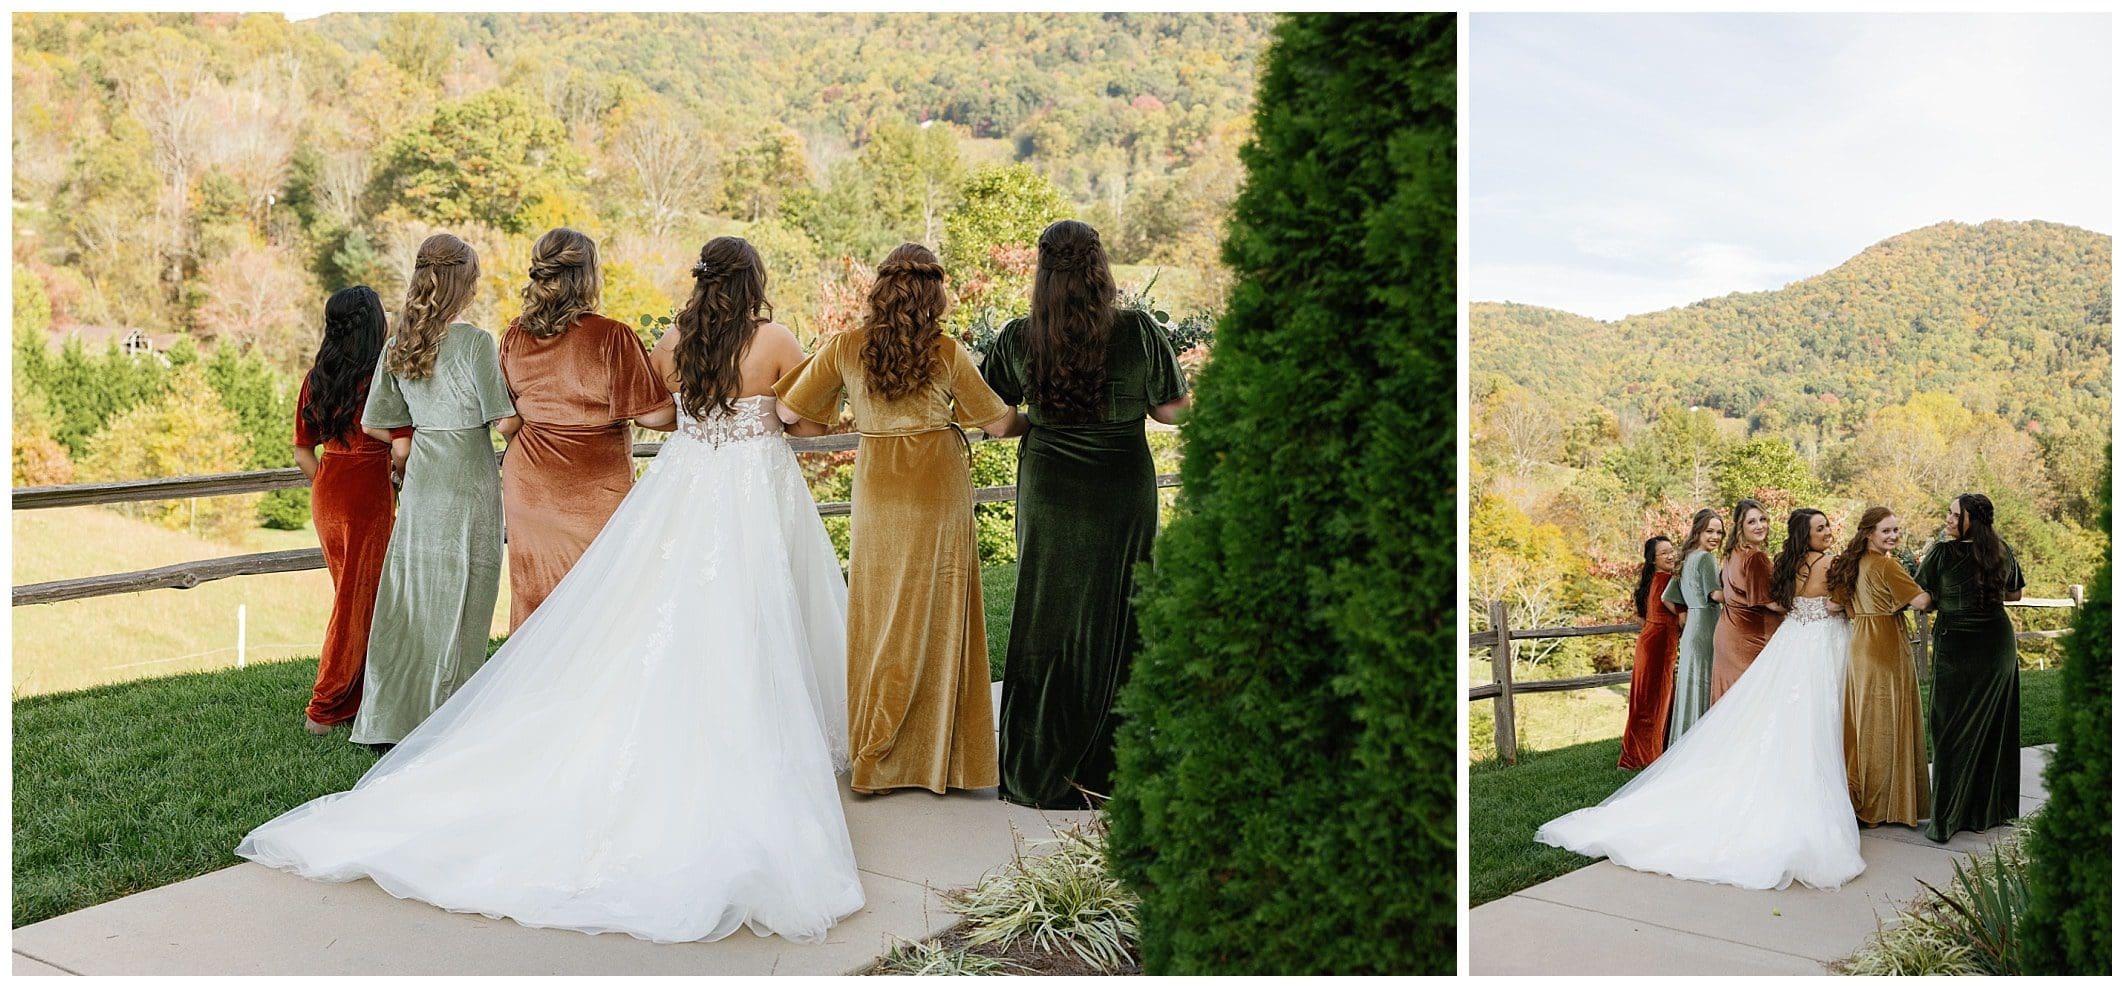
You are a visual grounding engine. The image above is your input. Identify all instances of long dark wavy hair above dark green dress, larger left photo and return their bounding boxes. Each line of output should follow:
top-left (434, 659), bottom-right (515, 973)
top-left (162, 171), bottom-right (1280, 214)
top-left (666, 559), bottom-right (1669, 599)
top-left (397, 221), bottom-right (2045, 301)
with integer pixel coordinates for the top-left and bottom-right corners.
top-left (1026, 219), bottom-right (1115, 423)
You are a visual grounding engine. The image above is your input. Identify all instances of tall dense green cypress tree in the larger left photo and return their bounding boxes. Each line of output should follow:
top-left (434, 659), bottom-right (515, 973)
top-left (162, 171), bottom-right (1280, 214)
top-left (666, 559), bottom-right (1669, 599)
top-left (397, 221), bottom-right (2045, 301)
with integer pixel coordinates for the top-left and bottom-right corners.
top-left (1109, 13), bottom-right (1457, 973)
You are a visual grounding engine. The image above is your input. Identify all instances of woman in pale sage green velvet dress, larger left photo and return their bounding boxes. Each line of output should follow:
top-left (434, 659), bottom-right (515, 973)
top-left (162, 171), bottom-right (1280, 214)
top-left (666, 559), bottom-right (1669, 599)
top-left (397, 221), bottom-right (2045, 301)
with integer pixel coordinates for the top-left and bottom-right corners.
top-left (353, 234), bottom-right (523, 746)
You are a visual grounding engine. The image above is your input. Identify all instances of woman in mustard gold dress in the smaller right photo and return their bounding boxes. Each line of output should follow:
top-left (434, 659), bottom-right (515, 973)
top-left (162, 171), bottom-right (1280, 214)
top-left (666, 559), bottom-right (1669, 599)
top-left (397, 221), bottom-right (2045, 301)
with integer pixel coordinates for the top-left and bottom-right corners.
top-left (1829, 508), bottom-right (1933, 827)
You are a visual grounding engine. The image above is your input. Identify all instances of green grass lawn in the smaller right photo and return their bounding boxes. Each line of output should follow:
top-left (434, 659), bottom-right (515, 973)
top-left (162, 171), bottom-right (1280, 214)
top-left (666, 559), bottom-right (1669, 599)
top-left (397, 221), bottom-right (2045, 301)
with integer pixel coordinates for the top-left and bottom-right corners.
top-left (1468, 669), bottom-right (2062, 905)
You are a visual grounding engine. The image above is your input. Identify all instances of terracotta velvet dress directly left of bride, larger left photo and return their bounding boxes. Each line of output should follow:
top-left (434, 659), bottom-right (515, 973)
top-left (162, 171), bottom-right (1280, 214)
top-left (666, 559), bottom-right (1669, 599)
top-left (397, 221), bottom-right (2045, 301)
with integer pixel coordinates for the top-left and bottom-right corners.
top-left (501, 312), bottom-right (671, 633)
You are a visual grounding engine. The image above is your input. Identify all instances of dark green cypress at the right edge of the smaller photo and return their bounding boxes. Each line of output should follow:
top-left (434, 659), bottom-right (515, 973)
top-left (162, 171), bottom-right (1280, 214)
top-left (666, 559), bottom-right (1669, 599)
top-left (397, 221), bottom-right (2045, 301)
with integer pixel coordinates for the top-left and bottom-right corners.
top-left (2020, 452), bottom-right (2116, 975)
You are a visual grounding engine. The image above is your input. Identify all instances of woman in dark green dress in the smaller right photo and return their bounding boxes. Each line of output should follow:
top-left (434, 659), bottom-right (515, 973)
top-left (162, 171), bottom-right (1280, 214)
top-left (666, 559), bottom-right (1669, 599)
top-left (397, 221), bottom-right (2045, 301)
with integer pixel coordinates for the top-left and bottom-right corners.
top-left (1918, 493), bottom-right (2026, 844)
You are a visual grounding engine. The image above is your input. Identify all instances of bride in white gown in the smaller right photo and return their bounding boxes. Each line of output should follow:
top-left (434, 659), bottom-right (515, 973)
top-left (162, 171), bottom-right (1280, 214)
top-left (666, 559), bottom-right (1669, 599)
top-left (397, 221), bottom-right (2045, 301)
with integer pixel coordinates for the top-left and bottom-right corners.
top-left (1534, 508), bottom-right (1865, 888)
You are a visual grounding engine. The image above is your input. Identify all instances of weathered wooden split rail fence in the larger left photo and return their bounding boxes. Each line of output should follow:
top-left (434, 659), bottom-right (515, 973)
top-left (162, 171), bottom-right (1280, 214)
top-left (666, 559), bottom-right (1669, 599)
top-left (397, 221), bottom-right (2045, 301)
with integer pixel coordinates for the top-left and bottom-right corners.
top-left (13, 431), bottom-right (1181, 608)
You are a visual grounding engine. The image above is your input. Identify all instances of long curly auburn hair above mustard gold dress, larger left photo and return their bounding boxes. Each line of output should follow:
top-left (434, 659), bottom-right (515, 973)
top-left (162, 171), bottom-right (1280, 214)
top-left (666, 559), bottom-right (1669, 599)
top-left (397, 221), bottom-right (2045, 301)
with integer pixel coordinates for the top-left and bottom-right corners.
top-left (862, 244), bottom-right (952, 402)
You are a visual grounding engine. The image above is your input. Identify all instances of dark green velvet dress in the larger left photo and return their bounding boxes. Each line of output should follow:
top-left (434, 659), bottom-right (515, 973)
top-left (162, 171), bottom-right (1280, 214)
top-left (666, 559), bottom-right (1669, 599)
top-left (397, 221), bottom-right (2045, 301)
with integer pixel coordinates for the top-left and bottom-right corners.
top-left (981, 310), bottom-right (1187, 810)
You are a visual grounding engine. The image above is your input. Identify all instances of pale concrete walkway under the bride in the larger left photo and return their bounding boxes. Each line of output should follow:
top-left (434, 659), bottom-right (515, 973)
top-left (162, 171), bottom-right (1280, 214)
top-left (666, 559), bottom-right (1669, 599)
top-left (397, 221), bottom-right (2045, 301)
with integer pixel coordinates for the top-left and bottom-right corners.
top-left (15, 679), bottom-right (1092, 975)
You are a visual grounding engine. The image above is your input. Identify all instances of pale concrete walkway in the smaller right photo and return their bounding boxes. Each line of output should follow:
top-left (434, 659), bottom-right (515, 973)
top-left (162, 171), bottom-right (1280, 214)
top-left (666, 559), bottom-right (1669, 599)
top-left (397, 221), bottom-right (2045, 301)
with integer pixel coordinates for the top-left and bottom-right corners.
top-left (1468, 746), bottom-right (2050, 975)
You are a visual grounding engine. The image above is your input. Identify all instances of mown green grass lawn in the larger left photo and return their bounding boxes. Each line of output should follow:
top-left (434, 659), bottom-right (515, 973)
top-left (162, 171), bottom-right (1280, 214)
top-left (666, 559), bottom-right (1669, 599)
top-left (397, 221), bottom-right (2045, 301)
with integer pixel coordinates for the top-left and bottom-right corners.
top-left (13, 565), bottom-right (1017, 926)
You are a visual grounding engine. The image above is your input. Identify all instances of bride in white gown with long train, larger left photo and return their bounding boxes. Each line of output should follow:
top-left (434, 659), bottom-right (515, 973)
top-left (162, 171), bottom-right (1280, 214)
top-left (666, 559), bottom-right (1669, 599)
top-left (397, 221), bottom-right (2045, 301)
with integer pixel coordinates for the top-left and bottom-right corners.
top-left (236, 238), bottom-right (862, 943)
